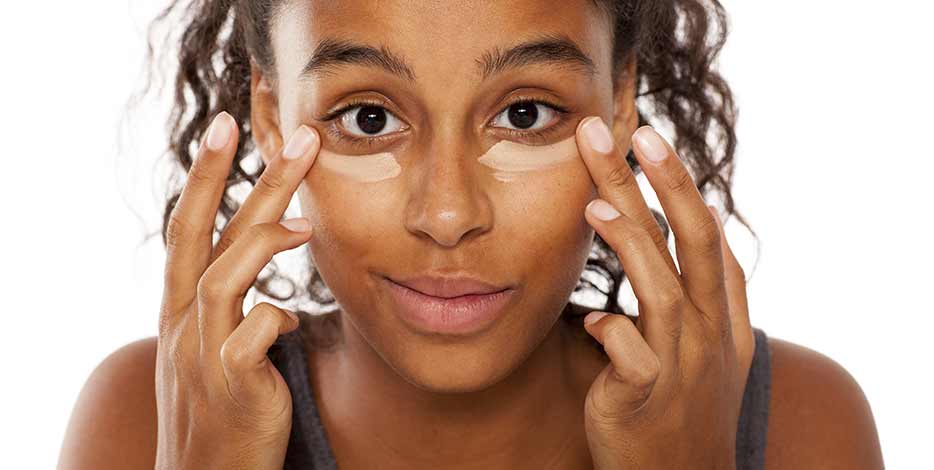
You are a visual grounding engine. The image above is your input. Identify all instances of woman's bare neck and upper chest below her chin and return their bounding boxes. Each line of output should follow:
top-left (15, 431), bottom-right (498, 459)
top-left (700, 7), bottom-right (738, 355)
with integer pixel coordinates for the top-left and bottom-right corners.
top-left (309, 310), bottom-right (605, 469)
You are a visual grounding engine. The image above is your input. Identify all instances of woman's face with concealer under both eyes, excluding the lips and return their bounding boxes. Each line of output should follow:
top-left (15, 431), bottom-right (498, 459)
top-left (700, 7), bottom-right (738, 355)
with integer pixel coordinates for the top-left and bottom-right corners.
top-left (253, 0), bottom-right (633, 391)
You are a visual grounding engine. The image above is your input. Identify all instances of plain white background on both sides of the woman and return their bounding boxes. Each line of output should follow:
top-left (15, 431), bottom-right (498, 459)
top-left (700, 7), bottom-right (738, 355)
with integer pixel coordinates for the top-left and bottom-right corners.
top-left (0, 0), bottom-right (934, 469)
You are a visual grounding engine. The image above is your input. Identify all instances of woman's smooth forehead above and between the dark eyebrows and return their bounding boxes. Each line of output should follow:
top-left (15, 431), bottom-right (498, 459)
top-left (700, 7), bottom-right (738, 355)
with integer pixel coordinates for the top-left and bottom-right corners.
top-left (271, 0), bottom-right (611, 87)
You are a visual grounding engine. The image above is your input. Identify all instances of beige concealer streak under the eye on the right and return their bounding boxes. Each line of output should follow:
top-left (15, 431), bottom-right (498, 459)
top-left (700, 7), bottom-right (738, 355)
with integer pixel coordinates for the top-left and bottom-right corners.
top-left (477, 136), bottom-right (578, 182)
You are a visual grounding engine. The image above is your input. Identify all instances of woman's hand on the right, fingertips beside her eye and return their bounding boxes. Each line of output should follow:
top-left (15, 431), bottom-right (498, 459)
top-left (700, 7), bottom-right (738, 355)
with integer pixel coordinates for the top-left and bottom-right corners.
top-left (577, 118), bottom-right (755, 470)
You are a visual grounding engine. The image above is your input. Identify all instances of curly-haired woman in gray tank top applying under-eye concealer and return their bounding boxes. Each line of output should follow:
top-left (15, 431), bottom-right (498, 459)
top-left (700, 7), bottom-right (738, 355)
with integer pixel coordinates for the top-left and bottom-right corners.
top-left (61, 0), bottom-right (882, 469)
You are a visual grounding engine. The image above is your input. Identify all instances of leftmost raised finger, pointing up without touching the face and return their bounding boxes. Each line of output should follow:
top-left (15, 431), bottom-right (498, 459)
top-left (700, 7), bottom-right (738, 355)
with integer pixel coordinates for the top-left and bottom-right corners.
top-left (162, 111), bottom-right (239, 320)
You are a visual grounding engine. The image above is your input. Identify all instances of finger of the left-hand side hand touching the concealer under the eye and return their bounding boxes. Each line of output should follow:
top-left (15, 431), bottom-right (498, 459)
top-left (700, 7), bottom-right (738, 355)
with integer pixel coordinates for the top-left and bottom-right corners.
top-left (211, 125), bottom-right (321, 263)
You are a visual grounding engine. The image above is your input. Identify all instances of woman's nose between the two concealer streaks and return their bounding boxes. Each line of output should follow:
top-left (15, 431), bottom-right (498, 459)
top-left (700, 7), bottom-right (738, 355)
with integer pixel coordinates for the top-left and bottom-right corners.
top-left (405, 136), bottom-right (493, 247)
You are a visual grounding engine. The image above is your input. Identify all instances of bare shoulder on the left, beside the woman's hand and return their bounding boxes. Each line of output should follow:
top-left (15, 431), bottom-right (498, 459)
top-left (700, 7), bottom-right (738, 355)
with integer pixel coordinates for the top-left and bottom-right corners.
top-left (58, 336), bottom-right (157, 470)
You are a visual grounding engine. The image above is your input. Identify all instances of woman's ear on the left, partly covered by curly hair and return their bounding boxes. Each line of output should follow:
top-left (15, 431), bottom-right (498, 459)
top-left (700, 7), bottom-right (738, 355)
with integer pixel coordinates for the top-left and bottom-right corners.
top-left (250, 59), bottom-right (282, 165)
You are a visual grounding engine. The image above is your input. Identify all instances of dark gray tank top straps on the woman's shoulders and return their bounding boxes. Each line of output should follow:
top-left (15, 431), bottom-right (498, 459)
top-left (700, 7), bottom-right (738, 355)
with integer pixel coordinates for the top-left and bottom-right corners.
top-left (268, 328), bottom-right (771, 470)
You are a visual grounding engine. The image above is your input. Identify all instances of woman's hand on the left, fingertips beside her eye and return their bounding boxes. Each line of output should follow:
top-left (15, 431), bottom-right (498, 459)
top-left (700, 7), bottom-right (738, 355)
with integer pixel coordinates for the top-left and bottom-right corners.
top-left (155, 113), bottom-right (320, 470)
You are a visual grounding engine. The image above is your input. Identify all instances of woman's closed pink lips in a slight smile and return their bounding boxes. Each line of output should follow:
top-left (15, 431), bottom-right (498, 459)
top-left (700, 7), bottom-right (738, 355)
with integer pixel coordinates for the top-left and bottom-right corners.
top-left (382, 276), bottom-right (516, 336)
